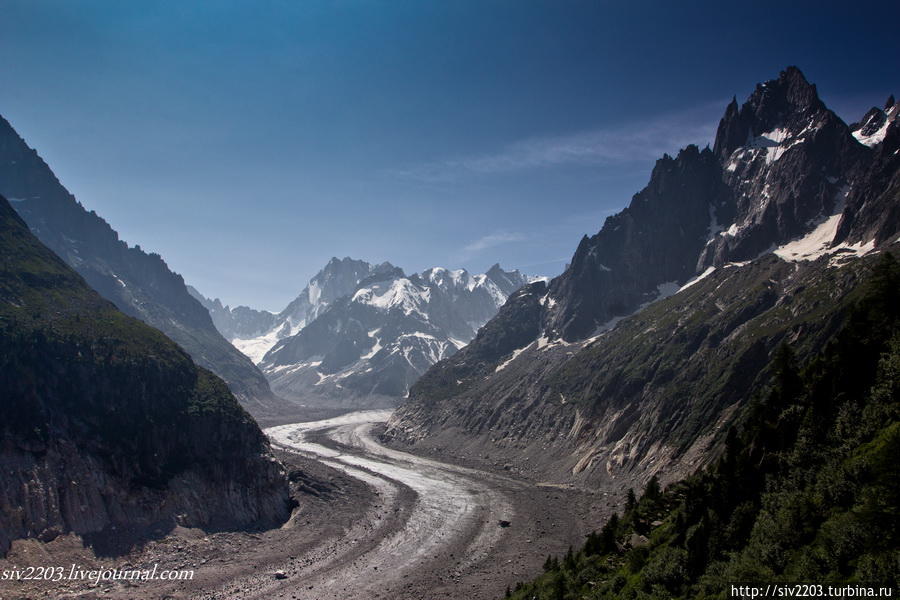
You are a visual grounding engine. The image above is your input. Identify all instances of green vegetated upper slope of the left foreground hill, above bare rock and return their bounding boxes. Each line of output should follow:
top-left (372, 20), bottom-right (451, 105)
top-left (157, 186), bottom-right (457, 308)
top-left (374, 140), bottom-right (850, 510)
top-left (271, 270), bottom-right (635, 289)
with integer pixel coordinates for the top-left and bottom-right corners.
top-left (0, 199), bottom-right (250, 433)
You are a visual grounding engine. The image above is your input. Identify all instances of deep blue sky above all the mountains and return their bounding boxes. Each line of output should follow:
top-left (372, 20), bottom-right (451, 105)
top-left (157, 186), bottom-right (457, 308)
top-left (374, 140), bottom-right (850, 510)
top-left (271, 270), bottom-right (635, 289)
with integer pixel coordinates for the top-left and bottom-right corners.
top-left (0, 0), bottom-right (900, 310)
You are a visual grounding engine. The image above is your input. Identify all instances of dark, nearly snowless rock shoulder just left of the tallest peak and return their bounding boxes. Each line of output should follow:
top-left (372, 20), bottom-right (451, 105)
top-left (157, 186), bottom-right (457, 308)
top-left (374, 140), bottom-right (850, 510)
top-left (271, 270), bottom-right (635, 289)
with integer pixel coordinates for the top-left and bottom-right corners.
top-left (542, 146), bottom-right (734, 340)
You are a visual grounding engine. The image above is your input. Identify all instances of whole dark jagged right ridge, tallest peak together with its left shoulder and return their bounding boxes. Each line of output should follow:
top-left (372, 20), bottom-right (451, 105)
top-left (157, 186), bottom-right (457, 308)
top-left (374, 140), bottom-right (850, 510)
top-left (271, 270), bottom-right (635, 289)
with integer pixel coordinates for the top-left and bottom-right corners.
top-left (428, 67), bottom-right (884, 354)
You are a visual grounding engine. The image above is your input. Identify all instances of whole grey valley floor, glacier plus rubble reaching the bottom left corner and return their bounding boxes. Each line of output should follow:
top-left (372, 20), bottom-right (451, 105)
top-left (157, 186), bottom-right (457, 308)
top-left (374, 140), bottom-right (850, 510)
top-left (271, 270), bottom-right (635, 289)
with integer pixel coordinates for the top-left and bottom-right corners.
top-left (0, 411), bottom-right (611, 600)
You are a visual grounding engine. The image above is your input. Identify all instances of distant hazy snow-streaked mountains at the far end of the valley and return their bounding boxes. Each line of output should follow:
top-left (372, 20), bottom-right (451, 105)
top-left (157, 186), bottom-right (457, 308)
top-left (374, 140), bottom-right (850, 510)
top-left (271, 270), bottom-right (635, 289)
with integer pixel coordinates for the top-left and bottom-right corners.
top-left (193, 258), bottom-right (527, 406)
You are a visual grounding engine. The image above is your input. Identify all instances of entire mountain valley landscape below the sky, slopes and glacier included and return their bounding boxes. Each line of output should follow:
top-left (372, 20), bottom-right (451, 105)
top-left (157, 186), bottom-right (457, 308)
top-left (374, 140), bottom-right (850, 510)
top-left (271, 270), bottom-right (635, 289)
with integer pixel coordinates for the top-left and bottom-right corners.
top-left (0, 61), bottom-right (900, 600)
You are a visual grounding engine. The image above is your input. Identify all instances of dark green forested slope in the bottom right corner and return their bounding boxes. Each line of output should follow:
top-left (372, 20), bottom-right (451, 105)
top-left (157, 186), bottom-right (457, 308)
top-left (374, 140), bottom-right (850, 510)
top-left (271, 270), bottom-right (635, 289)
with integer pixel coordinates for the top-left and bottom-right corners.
top-left (509, 253), bottom-right (900, 600)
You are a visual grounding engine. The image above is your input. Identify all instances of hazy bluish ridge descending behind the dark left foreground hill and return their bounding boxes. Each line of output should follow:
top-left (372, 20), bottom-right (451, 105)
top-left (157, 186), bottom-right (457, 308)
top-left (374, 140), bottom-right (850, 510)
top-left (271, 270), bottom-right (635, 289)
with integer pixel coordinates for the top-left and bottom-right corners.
top-left (0, 118), bottom-right (279, 413)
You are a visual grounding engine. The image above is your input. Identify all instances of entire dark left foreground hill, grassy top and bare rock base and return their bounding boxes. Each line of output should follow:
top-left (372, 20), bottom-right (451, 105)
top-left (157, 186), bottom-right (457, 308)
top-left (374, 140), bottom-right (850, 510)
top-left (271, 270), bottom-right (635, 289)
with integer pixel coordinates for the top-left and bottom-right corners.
top-left (0, 198), bottom-right (291, 552)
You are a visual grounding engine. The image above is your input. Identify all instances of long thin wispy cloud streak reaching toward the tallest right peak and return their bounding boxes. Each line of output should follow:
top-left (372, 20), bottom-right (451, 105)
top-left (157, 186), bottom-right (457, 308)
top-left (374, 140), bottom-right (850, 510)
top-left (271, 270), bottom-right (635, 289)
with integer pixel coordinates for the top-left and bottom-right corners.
top-left (388, 103), bottom-right (724, 183)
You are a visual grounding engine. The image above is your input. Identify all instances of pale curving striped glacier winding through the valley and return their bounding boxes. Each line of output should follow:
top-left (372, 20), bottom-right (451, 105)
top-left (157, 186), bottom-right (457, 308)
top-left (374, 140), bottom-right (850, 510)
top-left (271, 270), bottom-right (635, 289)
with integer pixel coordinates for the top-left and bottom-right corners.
top-left (254, 410), bottom-right (513, 600)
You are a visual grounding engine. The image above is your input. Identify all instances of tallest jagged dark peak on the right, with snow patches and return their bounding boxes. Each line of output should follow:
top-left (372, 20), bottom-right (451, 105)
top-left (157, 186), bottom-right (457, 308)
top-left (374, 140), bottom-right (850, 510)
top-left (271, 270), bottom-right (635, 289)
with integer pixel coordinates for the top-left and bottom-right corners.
top-left (700, 68), bottom-right (872, 268)
